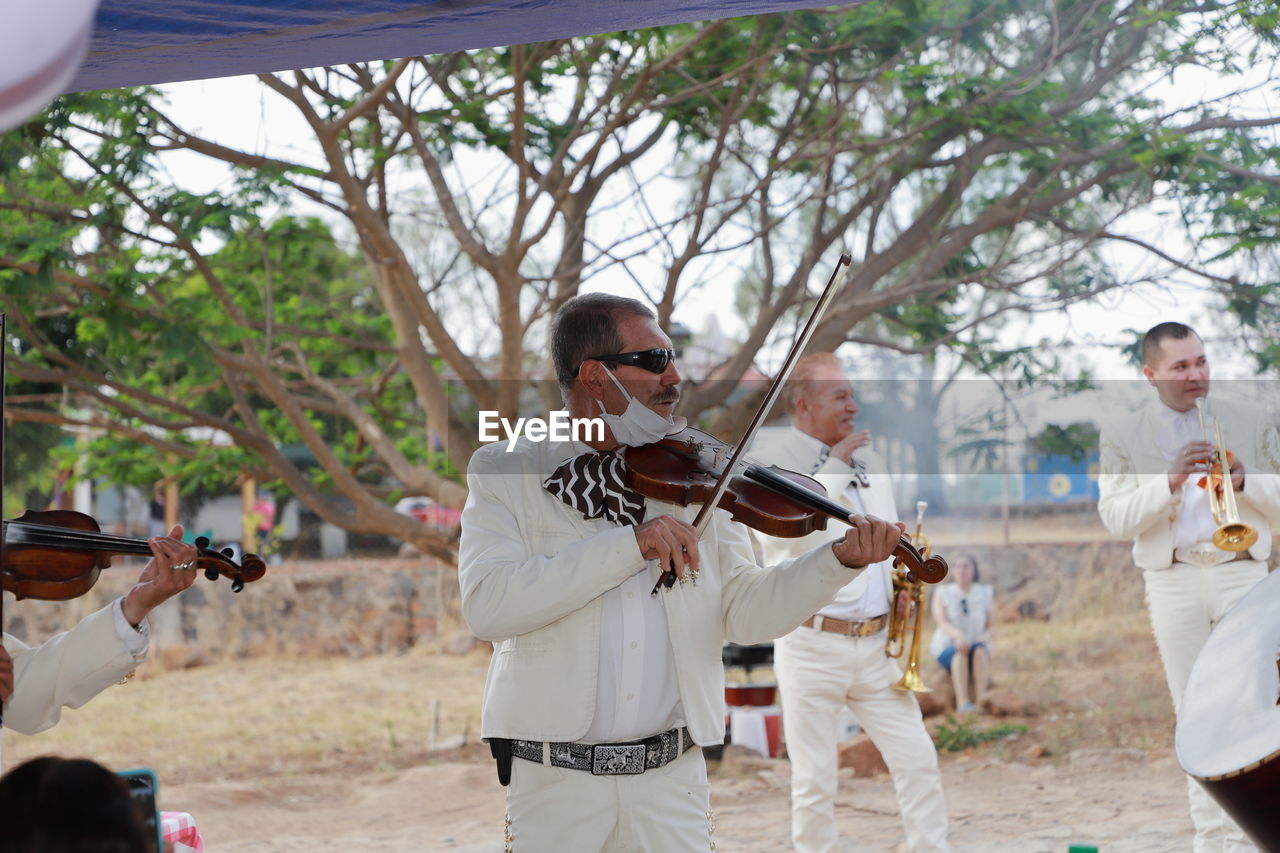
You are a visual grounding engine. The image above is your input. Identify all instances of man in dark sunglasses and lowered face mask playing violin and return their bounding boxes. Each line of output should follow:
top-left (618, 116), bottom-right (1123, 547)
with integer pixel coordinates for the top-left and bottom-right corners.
top-left (458, 293), bottom-right (902, 853)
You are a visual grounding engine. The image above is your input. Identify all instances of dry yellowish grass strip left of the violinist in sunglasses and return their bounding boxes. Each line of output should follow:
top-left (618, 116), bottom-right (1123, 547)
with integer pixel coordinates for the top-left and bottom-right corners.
top-left (4, 630), bottom-right (488, 784)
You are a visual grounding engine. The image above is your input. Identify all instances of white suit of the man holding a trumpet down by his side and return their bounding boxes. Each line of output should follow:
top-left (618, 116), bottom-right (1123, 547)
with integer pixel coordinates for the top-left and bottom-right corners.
top-left (750, 427), bottom-right (950, 853)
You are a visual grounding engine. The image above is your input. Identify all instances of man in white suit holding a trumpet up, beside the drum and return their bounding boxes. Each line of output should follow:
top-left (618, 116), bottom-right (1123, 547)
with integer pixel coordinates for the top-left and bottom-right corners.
top-left (1098, 323), bottom-right (1280, 852)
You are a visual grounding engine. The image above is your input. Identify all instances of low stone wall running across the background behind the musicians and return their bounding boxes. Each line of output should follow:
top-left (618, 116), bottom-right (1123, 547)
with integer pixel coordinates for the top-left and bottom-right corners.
top-left (4, 540), bottom-right (1264, 665)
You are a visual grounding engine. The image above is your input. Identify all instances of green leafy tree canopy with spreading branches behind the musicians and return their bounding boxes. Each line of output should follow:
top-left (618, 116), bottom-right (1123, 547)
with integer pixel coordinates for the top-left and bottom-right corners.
top-left (0, 0), bottom-right (1280, 545)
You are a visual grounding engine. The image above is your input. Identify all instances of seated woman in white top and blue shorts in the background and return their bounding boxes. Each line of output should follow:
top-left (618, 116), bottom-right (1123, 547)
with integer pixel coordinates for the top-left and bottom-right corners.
top-left (929, 555), bottom-right (996, 713)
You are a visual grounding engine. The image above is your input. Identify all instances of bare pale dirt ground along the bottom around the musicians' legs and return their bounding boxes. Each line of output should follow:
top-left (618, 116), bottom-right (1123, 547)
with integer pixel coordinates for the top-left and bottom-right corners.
top-left (165, 749), bottom-right (1192, 853)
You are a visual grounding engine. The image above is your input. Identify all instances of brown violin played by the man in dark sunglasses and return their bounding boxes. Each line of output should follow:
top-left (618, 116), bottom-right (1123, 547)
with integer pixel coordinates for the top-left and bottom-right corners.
top-left (622, 427), bottom-right (947, 587)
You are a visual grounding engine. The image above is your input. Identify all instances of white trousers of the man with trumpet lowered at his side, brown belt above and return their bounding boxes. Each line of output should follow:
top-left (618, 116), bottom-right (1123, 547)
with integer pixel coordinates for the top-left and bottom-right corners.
top-left (773, 628), bottom-right (950, 853)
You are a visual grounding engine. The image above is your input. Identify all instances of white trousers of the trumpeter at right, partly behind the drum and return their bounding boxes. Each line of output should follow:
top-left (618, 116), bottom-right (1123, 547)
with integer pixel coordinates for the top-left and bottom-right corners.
top-left (1142, 560), bottom-right (1267, 853)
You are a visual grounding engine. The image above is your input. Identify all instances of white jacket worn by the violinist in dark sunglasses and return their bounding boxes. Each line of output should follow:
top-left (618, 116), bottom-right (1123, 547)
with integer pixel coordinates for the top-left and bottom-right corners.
top-left (458, 438), bottom-right (860, 745)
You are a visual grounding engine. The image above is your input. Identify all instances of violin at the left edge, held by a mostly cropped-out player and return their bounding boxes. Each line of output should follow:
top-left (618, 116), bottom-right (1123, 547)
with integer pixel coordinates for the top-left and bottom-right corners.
top-left (0, 510), bottom-right (266, 601)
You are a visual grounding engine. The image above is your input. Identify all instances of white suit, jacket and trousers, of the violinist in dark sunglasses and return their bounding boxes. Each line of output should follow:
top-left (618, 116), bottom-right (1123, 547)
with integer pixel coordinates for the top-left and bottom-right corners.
top-left (458, 439), bottom-right (861, 850)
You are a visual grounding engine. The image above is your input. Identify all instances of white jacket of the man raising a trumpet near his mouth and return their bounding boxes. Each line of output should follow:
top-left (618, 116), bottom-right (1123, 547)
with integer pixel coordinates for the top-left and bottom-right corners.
top-left (1098, 400), bottom-right (1280, 571)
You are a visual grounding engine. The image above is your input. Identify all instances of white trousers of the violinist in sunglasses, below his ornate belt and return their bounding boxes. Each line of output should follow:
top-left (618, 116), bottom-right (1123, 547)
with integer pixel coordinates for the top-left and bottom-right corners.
top-left (506, 747), bottom-right (713, 853)
